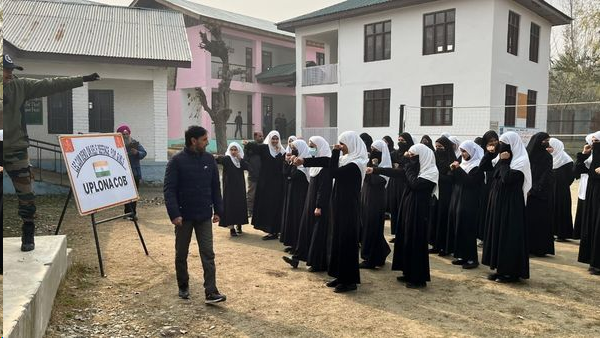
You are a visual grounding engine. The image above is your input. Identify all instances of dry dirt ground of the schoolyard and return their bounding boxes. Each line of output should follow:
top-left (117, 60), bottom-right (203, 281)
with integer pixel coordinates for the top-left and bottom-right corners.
top-left (4, 182), bottom-right (600, 337)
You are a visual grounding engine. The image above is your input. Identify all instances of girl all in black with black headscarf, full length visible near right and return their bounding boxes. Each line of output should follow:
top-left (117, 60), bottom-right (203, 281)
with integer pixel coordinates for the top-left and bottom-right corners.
top-left (525, 132), bottom-right (554, 257)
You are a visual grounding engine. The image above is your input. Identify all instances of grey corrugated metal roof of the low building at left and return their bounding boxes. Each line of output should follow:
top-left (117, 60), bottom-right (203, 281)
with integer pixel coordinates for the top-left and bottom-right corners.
top-left (3, 0), bottom-right (192, 62)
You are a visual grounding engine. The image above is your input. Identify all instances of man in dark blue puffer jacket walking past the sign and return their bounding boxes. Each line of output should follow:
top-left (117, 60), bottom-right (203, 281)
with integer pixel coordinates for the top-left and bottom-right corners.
top-left (163, 126), bottom-right (226, 304)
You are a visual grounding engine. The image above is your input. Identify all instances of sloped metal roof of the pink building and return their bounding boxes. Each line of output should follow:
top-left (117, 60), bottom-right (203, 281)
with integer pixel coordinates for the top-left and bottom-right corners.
top-left (137, 0), bottom-right (295, 37)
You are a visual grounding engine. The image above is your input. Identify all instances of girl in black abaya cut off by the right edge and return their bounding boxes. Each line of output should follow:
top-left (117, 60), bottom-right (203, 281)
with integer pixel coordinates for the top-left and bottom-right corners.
top-left (576, 131), bottom-right (600, 275)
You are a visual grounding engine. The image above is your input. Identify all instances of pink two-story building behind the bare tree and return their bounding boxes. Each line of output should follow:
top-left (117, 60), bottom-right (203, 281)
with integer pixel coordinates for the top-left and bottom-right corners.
top-left (131, 0), bottom-right (324, 143)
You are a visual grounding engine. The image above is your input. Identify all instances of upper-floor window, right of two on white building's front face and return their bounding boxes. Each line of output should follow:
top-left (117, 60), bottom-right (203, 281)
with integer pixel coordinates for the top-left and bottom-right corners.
top-left (423, 9), bottom-right (456, 55)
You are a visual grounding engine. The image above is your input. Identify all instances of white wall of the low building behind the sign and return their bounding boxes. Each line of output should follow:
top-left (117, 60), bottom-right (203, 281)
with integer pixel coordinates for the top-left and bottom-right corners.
top-left (19, 59), bottom-right (167, 162)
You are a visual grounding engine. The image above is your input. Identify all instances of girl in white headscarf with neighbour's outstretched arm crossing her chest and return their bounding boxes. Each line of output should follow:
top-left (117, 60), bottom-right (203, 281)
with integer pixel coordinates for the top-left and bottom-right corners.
top-left (359, 140), bottom-right (392, 269)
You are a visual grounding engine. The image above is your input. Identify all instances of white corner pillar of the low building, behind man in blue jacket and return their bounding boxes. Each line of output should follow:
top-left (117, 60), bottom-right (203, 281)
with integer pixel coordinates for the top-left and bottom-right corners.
top-left (152, 69), bottom-right (168, 162)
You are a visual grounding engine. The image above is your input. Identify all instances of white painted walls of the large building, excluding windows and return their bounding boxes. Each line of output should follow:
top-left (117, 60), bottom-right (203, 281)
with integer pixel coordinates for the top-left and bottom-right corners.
top-left (296, 0), bottom-right (550, 139)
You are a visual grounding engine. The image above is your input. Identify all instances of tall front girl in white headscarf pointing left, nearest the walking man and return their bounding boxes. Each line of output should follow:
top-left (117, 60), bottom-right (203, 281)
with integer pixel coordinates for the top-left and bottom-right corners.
top-left (295, 131), bottom-right (369, 293)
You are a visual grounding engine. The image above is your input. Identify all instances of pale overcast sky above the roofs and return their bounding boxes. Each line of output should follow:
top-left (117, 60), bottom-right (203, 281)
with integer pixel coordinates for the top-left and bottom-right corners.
top-left (92, 0), bottom-right (563, 22)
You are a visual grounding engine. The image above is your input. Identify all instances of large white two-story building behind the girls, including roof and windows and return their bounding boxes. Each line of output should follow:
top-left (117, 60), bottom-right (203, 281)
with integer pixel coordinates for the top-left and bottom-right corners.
top-left (278, 0), bottom-right (571, 143)
